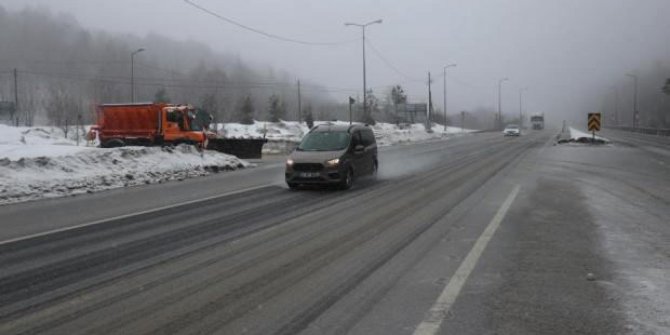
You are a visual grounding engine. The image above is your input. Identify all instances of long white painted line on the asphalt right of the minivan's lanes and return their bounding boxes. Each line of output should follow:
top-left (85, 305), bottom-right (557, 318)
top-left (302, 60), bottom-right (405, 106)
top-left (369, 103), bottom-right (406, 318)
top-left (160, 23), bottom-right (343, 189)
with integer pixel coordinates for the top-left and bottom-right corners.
top-left (414, 185), bottom-right (520, 335)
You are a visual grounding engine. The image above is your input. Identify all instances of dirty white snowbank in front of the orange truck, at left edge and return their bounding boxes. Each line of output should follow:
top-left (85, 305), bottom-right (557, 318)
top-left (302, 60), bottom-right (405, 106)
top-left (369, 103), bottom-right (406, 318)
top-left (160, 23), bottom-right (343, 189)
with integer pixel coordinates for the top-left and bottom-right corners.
top-left (0, 125), bottom-right (249, 204)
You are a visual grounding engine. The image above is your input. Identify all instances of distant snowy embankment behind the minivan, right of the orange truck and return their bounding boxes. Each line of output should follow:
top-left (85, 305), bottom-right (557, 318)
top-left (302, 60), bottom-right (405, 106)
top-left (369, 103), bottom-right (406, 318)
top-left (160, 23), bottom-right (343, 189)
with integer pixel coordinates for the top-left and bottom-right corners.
top-left (217, 121), bottom-right (474, 153)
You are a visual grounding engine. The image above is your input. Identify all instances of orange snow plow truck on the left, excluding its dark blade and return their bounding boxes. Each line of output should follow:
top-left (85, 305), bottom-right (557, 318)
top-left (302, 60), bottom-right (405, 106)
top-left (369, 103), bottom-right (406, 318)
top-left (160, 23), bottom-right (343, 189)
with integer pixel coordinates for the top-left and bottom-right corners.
top-left (90, 103), bottom-right (207, 148)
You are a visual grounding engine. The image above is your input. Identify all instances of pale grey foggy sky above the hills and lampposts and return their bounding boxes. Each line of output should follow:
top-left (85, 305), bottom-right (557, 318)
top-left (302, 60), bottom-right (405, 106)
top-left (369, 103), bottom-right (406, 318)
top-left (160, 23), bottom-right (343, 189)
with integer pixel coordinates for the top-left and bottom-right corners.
top-left (0, 0), bottom-right (670, 124)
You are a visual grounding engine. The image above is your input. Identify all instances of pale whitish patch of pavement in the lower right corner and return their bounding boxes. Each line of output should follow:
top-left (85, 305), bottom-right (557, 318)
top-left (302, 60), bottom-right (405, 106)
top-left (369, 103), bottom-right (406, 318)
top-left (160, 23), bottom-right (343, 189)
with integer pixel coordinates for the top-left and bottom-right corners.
top-left (583, 181), bottom-right (670, 335)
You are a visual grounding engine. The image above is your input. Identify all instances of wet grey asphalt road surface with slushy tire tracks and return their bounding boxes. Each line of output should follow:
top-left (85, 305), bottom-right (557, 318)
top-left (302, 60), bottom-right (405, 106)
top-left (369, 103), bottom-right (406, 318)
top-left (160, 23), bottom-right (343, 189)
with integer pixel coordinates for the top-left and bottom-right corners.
top-left (0, 131), bottom-right (670, 334)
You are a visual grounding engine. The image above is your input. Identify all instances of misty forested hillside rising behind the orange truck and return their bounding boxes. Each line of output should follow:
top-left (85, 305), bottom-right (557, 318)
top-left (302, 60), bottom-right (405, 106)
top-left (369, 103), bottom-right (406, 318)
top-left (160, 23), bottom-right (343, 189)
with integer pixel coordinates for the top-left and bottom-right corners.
top-left (0, 6), bottom-right (344, 125)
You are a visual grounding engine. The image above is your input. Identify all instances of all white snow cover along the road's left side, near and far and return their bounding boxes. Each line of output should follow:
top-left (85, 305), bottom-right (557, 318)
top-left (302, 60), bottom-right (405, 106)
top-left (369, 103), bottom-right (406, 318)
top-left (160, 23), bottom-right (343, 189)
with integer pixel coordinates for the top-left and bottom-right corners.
top-left (0, 121), bottom-right (472, 204)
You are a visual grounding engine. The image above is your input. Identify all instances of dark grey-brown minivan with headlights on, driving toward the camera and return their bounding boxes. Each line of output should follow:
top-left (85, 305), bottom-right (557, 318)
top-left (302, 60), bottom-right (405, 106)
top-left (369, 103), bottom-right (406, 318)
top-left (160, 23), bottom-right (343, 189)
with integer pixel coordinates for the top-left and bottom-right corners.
top-left (286, 124), bottom-right (378, 189)
